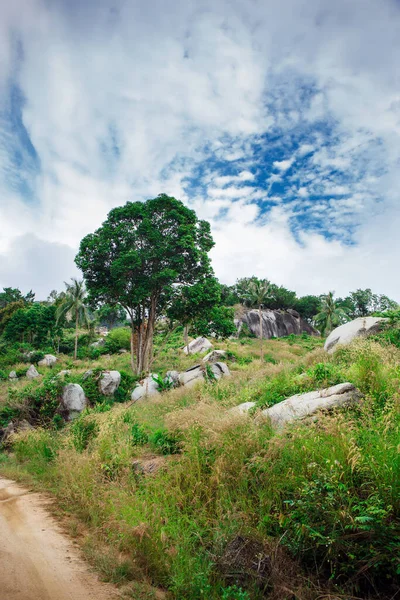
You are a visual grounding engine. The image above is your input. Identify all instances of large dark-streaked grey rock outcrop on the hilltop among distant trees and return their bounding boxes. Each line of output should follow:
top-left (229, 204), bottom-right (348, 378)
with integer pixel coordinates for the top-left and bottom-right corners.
top-left (235, 308), bottom-right (318, 339)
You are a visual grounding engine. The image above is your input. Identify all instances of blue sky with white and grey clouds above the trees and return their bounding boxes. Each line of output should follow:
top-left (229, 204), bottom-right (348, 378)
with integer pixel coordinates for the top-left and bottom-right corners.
top-left (0, 0), bottom-right (400, 300)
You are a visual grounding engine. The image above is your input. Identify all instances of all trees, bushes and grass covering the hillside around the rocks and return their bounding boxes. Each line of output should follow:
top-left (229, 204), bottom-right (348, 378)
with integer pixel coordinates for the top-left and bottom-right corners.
top-left (0, 195), bottom-right (400, 600)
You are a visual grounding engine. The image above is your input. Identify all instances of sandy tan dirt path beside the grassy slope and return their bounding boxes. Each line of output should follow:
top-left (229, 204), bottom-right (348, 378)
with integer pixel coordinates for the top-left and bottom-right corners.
top-left (0, 478), bottom-right (120, 600)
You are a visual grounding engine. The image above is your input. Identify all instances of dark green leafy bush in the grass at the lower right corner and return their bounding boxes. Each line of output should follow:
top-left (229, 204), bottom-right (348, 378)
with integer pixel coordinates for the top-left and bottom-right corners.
top-left (282, 463), bottom-right (400, 585)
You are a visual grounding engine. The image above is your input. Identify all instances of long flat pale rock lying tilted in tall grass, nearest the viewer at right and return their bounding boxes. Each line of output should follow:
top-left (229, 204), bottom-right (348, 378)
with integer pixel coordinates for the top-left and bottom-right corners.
top-left (262, 383), bottom-right (361, 429)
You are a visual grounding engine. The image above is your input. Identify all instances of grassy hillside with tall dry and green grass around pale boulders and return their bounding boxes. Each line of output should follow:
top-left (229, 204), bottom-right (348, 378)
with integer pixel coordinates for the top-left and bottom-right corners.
top-left (0, 336), bottom-right (400, 600)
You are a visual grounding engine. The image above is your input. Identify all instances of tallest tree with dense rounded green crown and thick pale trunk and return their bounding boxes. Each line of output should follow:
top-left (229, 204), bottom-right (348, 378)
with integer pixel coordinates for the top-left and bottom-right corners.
top-left (75, 194), bottom-right (214, 373)
